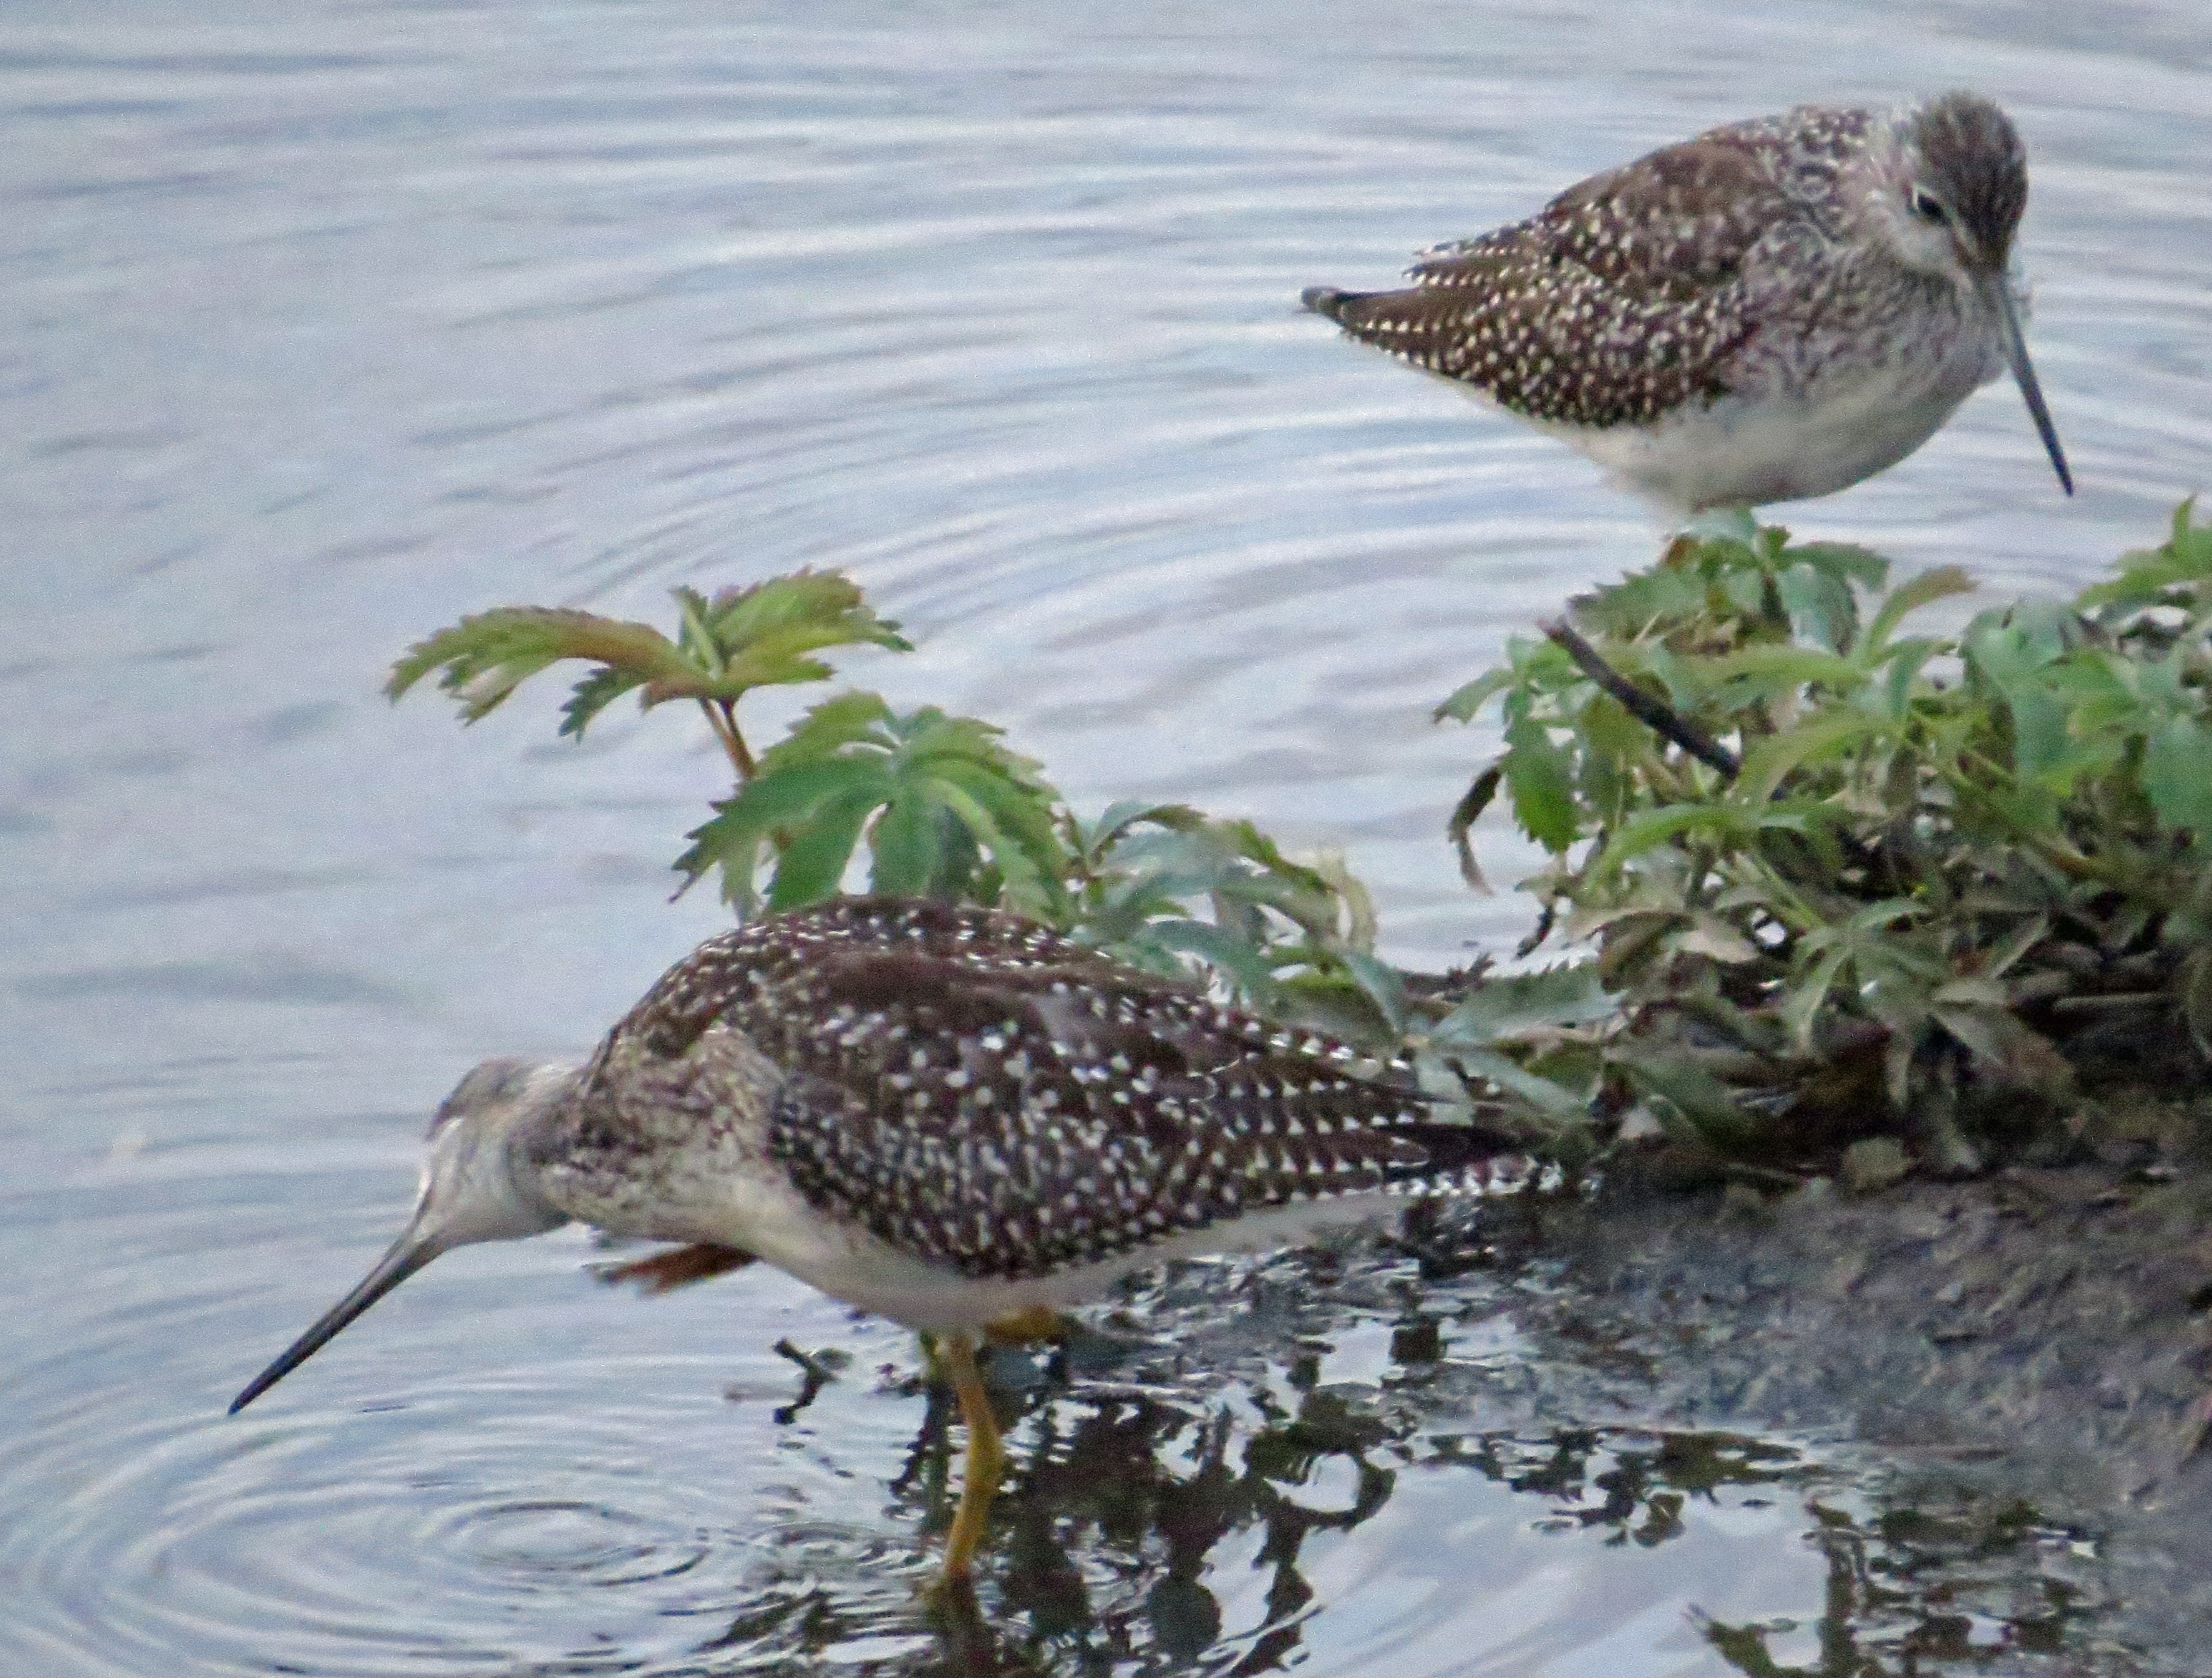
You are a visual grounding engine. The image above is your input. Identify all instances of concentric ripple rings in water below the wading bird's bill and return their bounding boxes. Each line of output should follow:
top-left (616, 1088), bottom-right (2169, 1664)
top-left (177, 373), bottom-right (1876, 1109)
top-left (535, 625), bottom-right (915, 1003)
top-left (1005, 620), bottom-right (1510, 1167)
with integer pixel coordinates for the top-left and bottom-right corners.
top-left (0, 1371), bottom-right (756, 1678)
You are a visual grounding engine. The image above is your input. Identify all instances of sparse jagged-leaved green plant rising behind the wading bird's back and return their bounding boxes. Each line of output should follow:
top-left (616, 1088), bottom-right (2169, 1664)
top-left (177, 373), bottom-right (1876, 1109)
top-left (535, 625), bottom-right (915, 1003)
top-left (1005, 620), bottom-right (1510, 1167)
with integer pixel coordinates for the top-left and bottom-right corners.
top-left (387, 570), bottom-right (1433, 1046)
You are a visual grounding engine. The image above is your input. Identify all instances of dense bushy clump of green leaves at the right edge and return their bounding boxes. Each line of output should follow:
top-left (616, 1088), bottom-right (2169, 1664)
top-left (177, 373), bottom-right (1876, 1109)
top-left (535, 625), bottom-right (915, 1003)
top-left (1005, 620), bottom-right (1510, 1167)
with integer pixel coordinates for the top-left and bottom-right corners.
top-left (1440, 506), bottom-right (2212, 1167)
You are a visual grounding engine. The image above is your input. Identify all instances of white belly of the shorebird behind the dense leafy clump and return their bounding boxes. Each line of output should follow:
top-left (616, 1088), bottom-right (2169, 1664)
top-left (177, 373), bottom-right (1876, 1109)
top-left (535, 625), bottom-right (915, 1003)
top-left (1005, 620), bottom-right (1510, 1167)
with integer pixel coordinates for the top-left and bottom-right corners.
top-left (1544, 358), bottom-right (1997, 513)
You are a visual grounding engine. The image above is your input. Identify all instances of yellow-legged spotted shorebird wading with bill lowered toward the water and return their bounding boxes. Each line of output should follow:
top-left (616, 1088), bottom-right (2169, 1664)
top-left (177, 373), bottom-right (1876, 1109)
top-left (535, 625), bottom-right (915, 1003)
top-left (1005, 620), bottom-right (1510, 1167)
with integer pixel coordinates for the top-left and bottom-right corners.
top-left (230, 898), bottom-right (1517, 1585)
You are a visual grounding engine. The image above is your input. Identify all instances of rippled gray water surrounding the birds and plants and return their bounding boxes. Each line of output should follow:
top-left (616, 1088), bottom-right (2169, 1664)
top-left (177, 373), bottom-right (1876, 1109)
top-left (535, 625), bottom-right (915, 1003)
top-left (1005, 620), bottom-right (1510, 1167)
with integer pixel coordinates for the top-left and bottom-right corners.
top-left (0, 0), bottom-right (2212, 1678)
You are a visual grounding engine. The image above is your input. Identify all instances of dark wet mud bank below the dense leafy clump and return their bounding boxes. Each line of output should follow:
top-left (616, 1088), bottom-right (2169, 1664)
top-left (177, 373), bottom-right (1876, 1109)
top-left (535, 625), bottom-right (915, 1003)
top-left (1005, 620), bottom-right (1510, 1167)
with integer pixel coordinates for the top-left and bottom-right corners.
top-left (1460, 1167), bottom-right (2212, 1671)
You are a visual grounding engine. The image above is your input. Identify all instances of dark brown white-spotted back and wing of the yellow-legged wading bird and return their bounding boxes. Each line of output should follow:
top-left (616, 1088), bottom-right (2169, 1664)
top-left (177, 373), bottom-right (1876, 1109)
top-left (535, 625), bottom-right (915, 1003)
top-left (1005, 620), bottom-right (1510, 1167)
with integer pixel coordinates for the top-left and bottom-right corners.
top-left (617, 898), bottom-right (1511, 1276)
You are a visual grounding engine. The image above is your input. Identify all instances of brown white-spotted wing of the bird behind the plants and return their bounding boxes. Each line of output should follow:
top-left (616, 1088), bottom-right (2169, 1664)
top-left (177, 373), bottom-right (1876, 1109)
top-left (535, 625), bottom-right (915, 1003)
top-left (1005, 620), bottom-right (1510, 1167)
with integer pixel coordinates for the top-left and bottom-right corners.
top-left (1307, 113), bottom-right (1864, 429)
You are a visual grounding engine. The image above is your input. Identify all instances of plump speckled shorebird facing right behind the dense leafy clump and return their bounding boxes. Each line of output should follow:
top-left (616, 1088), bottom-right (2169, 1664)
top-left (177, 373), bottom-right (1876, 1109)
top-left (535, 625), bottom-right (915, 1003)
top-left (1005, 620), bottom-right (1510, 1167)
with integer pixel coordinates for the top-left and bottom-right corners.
top-left (1303, 93), bottom-right (2073, 513)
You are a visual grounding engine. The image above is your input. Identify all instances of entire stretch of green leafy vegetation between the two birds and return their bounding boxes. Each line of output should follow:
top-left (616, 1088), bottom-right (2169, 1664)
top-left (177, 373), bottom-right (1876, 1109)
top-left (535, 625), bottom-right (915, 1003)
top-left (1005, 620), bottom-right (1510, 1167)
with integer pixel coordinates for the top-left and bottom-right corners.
top-left (387, 504), bottom-right (2212, 1188)
